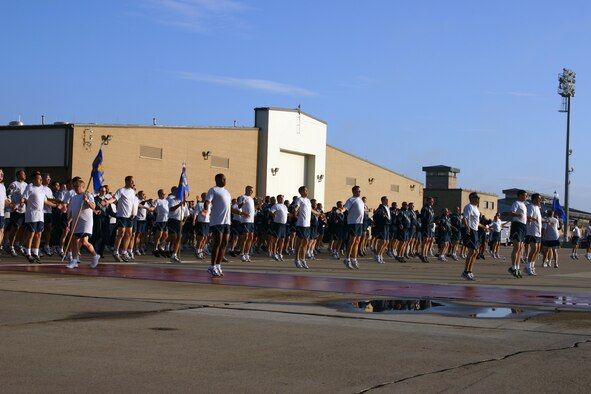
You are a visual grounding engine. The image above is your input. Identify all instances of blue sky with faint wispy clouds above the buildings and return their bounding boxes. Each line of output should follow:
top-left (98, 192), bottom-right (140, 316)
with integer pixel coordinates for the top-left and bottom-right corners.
top-left (0, 0), bottom-right (591, 211)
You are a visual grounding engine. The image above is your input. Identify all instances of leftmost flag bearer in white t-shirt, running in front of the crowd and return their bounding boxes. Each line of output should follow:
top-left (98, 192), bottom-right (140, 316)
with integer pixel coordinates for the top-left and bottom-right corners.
top-left (67, 180), bottom-right (101, 269)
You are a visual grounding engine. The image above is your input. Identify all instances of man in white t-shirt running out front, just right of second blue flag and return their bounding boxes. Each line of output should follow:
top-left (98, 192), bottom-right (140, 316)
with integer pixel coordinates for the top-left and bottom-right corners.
top-left (202, 173), bottom-right (232, 277)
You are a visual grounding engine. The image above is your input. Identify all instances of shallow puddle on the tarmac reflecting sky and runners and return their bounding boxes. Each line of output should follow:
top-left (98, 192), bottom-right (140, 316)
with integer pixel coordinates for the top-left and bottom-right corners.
top-left (337, 299), bottom-right (548, 319)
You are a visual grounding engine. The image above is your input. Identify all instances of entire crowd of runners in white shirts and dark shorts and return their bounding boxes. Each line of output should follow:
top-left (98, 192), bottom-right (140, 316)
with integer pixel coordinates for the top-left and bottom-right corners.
top-left (0, 170), bottom-right (591, 280)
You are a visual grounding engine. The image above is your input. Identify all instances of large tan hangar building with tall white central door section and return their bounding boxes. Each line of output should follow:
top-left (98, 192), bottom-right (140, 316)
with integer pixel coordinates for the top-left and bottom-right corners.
top-left (0, 108), bottom-right (423, 207)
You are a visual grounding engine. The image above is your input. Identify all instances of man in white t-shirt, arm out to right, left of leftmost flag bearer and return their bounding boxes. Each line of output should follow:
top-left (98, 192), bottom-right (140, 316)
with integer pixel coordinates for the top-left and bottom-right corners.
top-left (21, 172), bottom-right (57, 263)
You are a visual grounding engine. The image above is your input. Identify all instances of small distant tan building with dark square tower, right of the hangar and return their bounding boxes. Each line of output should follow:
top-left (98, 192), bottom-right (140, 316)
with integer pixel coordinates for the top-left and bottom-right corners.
top-left (423, 165), bottom-right (499, 219)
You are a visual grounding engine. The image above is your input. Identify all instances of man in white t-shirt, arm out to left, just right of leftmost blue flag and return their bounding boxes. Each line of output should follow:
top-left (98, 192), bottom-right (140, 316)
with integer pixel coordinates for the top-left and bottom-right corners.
top-left (101, 175), bottom-right (136, 263)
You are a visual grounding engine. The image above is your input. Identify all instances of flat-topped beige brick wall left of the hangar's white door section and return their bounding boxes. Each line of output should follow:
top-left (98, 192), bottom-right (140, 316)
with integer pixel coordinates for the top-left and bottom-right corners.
top-left (72, 124), bottom-right (258, 199)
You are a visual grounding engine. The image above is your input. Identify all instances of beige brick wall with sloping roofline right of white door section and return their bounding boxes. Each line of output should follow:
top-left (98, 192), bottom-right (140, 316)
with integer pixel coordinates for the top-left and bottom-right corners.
top-left (323, 145), bottom-right (423, 210)
